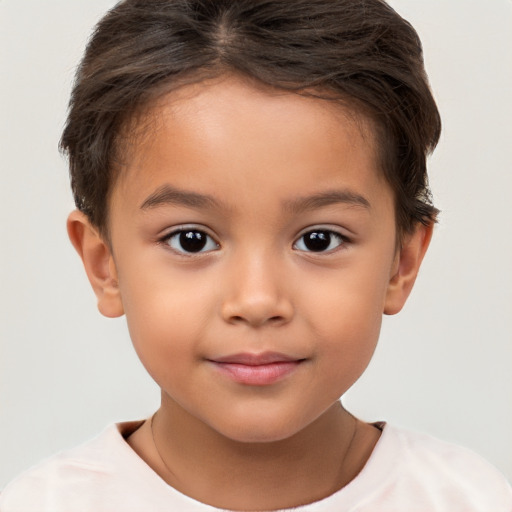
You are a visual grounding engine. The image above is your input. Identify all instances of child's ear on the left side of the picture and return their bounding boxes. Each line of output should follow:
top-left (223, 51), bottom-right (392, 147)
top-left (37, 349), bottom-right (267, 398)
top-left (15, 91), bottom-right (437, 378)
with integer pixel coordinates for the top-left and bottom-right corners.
top-left (67, 210), bottom-right (124, 318)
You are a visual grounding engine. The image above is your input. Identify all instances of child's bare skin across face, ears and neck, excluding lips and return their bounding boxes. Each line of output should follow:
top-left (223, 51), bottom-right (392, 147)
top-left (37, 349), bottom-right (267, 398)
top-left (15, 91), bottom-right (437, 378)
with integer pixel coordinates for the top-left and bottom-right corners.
top-left (68, 76), bottom-right (432, 510)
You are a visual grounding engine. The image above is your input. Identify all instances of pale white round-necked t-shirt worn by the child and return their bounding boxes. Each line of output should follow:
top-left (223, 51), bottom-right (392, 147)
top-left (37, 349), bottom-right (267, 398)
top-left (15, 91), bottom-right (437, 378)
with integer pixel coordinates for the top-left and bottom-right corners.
top-left (0, 421), bottom-right (512, 512)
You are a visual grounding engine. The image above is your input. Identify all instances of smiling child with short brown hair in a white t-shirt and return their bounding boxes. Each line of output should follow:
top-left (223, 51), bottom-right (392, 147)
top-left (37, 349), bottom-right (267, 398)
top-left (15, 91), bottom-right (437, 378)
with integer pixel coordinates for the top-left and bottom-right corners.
top-left (0, 0), bottom-right (512, 512)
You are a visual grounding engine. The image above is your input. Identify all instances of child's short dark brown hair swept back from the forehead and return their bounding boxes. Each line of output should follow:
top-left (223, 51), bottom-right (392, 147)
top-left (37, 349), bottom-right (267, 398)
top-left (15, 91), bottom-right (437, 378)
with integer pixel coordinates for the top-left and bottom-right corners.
top-left (61, 0), bottom-right (441, 238)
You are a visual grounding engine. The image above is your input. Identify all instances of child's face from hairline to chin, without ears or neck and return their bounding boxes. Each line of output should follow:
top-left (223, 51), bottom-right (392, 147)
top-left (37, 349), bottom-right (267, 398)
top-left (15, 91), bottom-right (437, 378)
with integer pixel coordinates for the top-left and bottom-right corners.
top-left (95, 74), bottom-right (412, 441)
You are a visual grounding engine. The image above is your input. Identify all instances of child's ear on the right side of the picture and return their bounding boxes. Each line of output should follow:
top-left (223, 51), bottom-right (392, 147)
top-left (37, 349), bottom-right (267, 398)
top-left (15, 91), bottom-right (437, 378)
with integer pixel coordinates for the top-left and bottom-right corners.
top-left (384, 223), bottom-right (434, 315)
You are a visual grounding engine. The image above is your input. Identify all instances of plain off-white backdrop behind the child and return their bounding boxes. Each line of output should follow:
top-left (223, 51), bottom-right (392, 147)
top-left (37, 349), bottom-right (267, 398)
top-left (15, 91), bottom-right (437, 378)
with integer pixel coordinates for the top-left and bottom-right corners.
top-left (0, 0), bottom-right (512, 489)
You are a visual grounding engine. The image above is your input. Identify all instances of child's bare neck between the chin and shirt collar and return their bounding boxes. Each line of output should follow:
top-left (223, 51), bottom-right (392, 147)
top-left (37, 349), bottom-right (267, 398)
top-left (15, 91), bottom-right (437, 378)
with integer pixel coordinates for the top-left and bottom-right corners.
top-left (148, 395), bottom-right (373, 510)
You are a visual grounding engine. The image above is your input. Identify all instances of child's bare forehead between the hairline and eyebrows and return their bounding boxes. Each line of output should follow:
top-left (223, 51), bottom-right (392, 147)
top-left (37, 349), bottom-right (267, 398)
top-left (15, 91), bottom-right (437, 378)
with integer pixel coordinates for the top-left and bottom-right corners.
top-left (113, 76), bottom-right (388, 212)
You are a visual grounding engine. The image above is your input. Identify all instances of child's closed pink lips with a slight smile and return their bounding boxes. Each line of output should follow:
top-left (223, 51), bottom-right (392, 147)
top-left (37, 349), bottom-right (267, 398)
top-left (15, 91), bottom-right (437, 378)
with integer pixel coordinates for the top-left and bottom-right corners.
top-left (211, 352), bottom-right (304, 386)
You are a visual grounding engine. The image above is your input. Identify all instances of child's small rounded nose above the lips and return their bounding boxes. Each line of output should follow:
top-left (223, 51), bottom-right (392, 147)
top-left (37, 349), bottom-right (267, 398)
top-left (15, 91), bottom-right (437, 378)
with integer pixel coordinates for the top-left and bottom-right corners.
top-left (222, 249), bottom-right (294, 327)
